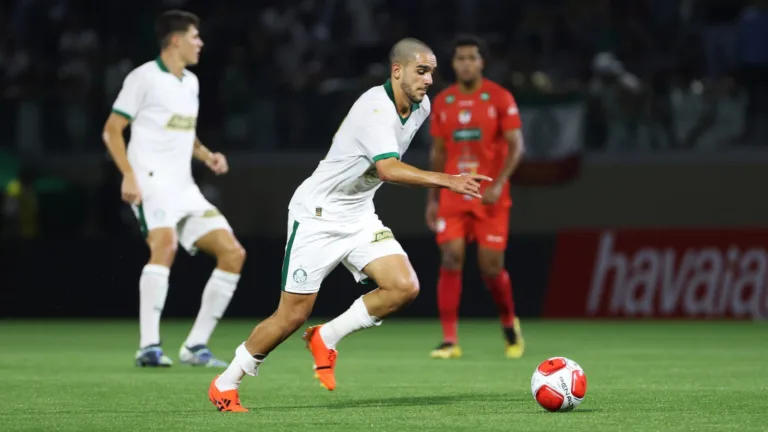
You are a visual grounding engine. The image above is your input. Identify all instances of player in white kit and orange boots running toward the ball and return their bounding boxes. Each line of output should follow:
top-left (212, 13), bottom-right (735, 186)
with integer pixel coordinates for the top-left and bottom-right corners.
top-left (208, 39), bottom-right (491, 412)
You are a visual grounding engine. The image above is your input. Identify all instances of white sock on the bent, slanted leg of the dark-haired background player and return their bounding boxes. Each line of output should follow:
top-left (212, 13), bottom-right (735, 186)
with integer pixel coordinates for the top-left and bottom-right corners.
top-left (184, 269), bottom-right (240, 347)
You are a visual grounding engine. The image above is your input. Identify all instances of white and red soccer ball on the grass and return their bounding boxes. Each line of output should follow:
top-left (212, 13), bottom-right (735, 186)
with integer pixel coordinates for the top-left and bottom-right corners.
top-left (531, 357), bottom-right (587, 412)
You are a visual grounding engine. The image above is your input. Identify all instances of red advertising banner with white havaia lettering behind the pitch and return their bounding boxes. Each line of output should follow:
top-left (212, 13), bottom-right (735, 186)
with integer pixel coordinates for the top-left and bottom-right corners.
top-left (543, 230), bottom-right (768, 319)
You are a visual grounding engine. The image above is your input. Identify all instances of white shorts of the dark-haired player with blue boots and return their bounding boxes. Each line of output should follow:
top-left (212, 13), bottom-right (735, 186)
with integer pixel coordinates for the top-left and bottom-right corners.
top-left (131, 184), bottom-right (232, 255)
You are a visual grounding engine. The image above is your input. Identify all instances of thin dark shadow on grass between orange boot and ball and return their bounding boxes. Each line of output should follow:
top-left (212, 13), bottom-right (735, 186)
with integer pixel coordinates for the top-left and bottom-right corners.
top-left (259, 393), bottom-right (527, 410)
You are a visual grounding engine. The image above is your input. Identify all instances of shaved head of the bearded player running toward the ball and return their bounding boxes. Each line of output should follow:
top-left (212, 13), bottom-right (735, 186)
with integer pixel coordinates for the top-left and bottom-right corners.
top-left (389, 38), bottom-right (437, 108)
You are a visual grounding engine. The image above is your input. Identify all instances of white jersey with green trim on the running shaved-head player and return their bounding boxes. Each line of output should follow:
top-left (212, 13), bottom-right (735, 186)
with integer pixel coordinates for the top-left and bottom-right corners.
top-left (288, 80), bottom-right (430, 221)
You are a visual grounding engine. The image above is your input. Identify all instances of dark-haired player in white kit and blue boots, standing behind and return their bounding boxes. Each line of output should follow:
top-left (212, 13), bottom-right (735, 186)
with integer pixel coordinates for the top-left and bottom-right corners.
top-left (103, 11), bottom-right (245, 367)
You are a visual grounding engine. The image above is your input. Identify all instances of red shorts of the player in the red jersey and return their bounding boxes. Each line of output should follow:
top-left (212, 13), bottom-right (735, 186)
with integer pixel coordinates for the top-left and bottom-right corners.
top-left (437, 205), bottom-right (510, 251)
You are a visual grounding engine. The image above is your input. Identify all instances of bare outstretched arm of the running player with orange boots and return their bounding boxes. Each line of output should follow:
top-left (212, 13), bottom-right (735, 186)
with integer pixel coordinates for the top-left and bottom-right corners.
top-left (376, 158), bottom-right (493, 198)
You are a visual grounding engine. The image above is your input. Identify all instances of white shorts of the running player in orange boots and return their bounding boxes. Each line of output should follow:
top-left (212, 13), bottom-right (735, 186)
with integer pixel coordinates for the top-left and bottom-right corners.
top-left (282, 212), bottom-right (407, 294)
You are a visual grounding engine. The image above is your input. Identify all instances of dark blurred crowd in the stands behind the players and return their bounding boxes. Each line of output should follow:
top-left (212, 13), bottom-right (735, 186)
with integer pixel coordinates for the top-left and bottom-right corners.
top-left (0, 0), bottom-right (768, 155)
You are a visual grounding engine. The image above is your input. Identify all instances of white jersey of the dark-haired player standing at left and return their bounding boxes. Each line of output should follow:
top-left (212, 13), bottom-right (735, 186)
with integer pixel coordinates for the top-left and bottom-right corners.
top-left (112, 57), bottom-right (200, 189)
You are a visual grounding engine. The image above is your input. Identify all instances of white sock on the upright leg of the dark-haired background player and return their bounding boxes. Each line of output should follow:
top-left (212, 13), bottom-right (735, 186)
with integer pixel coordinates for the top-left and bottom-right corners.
top-left (139, 264), bottom-right (171, 348)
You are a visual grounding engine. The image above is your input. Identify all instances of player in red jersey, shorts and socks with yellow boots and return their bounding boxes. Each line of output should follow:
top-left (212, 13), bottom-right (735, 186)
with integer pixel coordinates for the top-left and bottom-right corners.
top-left (426, 36), bottom-right (524, 358)
